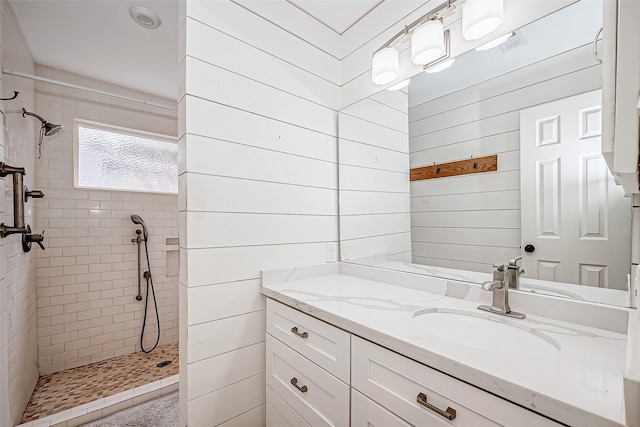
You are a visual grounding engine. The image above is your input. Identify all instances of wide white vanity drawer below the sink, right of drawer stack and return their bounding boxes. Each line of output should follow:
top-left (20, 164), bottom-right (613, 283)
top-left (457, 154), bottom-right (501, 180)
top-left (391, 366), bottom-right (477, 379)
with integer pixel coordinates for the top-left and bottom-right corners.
top-left (351, 336), bottom-right (560, 427)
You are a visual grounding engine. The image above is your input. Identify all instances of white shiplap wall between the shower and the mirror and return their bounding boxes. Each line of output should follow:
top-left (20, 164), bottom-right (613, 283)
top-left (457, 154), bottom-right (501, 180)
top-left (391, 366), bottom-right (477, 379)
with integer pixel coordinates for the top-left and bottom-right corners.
top-left (179, 1), bottom-right (340, 427)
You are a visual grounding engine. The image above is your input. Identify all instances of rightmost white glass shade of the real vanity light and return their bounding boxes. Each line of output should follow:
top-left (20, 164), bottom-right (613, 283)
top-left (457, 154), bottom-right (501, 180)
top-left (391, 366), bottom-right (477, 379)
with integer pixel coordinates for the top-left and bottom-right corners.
top-left (462, 0), bottom-right (504, 40)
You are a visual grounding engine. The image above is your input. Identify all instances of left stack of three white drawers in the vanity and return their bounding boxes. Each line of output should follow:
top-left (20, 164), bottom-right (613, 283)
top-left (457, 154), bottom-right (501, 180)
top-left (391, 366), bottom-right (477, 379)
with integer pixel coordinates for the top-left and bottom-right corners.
top-left (266, 299), bottom-right (350, 427)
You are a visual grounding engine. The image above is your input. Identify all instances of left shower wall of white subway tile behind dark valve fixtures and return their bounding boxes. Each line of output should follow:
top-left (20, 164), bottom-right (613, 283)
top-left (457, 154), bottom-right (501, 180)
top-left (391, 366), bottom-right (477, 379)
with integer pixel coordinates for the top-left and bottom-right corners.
top-left (0, 1), bottom-right (38, 426)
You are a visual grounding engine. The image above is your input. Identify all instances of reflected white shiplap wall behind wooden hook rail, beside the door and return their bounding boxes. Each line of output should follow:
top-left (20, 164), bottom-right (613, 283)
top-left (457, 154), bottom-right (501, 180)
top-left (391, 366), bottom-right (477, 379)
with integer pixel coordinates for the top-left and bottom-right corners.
top-left (409, 45), bottom-right (601, 272)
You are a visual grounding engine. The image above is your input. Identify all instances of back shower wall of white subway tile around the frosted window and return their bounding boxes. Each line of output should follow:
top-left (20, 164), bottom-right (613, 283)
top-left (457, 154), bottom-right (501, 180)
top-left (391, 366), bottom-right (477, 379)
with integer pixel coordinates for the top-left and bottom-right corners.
top-left (34, 66), bottom-right (178, 375)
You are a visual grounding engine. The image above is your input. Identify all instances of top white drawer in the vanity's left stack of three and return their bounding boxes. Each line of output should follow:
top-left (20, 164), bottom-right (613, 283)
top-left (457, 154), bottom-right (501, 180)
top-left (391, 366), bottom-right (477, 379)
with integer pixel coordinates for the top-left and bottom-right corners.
top-left (267, 299), bottom-right (351, 384)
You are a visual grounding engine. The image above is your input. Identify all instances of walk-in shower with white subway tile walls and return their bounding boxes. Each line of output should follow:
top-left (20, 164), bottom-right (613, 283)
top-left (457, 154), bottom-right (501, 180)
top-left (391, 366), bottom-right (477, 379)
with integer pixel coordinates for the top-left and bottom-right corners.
top-left (0, 2), bottom-right (178, 427)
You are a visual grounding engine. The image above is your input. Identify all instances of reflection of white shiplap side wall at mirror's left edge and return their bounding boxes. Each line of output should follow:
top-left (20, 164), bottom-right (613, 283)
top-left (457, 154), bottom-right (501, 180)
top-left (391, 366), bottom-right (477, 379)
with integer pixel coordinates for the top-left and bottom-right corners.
top-left (338, 90), bottom-right (411, 262)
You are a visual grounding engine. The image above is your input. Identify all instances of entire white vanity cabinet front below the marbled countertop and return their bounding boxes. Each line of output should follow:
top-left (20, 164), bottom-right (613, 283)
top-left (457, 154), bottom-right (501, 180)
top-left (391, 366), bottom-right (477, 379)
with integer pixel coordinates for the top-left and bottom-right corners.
top-left (266, 299), bottom-right (560, 427)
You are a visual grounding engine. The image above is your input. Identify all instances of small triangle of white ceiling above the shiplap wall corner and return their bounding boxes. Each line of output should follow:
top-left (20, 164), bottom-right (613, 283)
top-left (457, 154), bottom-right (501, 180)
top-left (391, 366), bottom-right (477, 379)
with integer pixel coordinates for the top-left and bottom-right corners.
top-left (287, 0), bottom-right (384, 34)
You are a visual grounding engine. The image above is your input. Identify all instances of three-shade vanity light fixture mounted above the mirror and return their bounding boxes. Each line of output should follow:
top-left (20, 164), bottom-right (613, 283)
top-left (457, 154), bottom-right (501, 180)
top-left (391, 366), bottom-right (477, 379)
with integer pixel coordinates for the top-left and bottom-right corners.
top-left (371, 0), bottom-right (504, 85)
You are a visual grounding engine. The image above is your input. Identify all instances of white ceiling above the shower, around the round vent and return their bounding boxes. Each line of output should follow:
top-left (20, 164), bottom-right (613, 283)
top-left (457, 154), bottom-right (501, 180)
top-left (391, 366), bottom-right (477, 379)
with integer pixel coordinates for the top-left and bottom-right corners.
top-left (9, 0), bottom-right (178, 100)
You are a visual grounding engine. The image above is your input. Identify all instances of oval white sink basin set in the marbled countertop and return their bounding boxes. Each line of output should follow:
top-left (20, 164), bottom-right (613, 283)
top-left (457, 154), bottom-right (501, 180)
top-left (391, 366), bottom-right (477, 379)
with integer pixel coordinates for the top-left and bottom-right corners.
top-left (412, 308), bottom-right (560, 357)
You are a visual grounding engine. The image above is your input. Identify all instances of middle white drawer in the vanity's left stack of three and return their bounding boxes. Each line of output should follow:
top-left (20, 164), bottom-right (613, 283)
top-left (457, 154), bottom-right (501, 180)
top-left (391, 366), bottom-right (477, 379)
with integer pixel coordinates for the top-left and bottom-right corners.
top-left (267, 334), bottom-right (349, 427)
